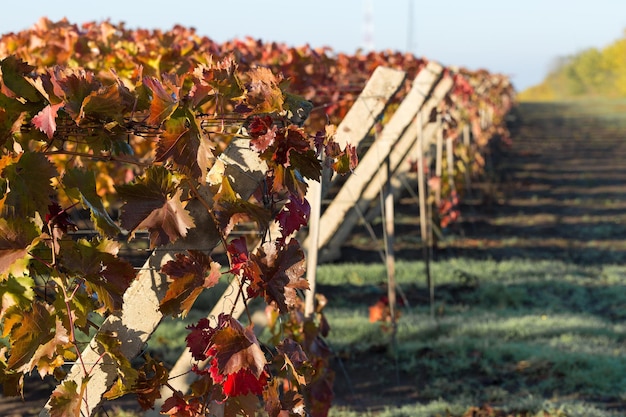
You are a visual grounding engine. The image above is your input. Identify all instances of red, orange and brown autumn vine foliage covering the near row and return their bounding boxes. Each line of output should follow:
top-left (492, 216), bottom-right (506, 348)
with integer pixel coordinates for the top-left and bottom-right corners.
top-left (0, 19), bottom-right (511, 416)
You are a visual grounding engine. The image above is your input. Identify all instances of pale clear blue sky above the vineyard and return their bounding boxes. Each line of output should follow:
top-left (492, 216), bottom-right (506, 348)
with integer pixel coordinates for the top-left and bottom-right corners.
top-left (0, 0), bottom-right (626, 90)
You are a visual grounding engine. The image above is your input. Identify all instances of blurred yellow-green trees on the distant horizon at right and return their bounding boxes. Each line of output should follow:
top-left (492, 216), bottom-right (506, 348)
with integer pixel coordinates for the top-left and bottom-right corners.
top-left (518, 31), bottom-right (626, 101)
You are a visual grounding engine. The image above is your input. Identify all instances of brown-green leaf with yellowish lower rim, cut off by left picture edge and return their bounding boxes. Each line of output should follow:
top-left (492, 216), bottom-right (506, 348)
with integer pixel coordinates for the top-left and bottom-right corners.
top-left (0, 218), bottom-right (41, 279)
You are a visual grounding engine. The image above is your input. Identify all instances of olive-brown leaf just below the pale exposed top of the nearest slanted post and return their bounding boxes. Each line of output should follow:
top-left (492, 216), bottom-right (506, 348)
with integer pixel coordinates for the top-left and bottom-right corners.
top-left (213, 177), bottom-right (271, 235)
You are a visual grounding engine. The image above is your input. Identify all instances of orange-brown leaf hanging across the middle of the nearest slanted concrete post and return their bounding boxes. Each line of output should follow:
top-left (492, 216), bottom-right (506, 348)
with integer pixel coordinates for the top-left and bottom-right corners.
top-left (159, 250), bottom-right (221, 318)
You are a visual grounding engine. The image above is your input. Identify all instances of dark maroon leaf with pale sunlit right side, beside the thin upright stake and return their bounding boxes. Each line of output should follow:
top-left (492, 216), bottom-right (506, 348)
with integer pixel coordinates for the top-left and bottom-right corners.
top-left (244, 239), bottom-right (309, 313)
